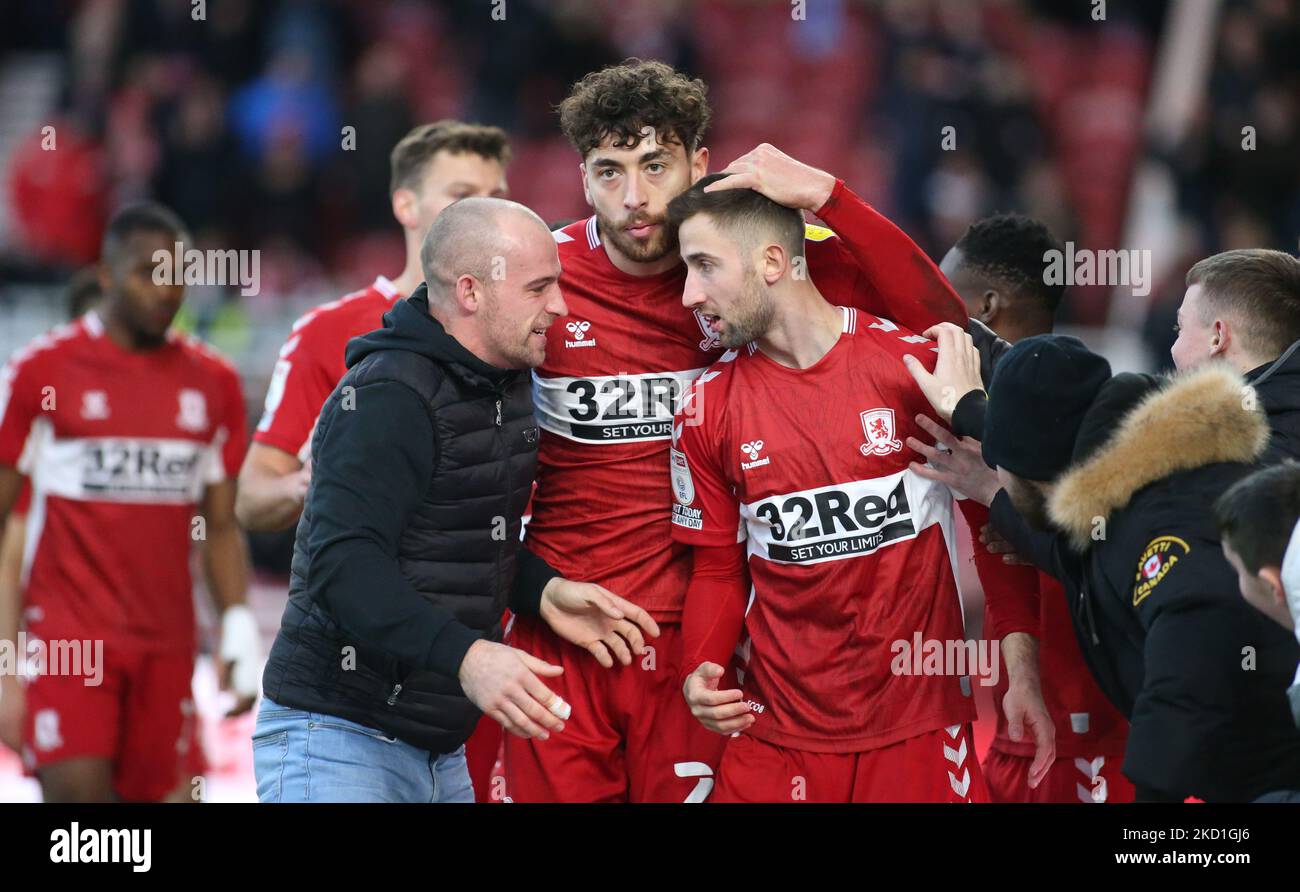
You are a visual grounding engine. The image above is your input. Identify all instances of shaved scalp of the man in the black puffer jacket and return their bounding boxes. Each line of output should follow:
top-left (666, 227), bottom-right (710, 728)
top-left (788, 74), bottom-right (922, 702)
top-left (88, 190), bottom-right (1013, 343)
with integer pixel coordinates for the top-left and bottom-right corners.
top-left (420, 198), bottom-right (551, 302)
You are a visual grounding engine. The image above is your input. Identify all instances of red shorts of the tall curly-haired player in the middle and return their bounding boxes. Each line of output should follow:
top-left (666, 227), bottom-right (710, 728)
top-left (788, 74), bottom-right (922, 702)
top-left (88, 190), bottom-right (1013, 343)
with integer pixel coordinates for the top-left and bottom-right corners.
top-left (491, 616), bottom-right (727, 802)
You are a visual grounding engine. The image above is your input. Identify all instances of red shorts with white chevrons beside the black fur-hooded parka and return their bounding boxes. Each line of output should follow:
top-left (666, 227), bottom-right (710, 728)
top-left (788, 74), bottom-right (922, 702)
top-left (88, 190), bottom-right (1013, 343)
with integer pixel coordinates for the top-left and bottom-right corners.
top-left (984, 749), bottom-right (1134, 802)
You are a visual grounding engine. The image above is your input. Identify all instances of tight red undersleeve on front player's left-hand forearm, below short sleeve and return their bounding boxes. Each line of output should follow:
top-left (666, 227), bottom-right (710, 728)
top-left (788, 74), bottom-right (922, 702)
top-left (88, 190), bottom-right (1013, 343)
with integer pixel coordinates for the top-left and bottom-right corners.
top-left (677, 544), bottom-right (749, 684)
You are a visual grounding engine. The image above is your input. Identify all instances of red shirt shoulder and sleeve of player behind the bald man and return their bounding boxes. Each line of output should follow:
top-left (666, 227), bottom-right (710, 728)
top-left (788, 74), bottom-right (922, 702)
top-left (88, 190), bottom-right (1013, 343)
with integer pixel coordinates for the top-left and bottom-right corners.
top-left (252, 276), bottom-right (400, 462)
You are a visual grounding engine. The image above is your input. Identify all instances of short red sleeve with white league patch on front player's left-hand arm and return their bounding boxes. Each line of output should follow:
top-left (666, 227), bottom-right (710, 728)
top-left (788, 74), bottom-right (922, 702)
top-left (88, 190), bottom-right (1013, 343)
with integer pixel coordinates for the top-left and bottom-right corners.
top-left (668, 372), bottom-right (744, 545)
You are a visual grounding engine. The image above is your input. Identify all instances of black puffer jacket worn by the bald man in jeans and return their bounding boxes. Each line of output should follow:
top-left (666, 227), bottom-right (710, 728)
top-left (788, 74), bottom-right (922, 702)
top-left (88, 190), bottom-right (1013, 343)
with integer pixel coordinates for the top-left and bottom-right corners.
top-left (263, 285), bottom-right (537, 753)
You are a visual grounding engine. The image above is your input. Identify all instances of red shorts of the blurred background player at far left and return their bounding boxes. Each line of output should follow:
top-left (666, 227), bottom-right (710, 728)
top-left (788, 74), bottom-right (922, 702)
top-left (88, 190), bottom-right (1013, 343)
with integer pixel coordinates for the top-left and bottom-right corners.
top-left (23, 649), bottom-right (204, 802)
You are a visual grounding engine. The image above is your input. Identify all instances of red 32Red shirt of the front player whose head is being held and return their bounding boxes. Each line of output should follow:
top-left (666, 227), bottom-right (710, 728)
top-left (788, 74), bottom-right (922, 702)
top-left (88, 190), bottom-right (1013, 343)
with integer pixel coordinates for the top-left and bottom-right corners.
top-left (671, 306), bottom-right (975, 753)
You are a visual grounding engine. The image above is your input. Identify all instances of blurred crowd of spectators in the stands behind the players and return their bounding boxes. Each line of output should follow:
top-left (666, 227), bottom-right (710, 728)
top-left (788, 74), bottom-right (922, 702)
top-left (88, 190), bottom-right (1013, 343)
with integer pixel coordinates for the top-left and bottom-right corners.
top-left (0, 0), bottom-right (1300, 338)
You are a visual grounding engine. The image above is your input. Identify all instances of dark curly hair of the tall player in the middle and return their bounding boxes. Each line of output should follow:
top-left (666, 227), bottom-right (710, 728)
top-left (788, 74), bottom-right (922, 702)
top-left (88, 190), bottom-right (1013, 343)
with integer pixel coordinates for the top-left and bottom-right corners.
top-left (559, 59), bottom-right (711, 159)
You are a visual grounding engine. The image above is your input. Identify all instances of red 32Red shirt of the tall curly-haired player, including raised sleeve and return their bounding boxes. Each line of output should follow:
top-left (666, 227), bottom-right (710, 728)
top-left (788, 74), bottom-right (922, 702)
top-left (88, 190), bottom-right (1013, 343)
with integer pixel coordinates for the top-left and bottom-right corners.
top-left (525, 181), bottom-right (965, 622)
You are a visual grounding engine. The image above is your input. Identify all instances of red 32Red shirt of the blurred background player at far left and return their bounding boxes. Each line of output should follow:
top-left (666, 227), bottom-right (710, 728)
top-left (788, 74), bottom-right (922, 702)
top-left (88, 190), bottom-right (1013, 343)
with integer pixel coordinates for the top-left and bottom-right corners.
top-left (0, 311), bottom-right (247, 650)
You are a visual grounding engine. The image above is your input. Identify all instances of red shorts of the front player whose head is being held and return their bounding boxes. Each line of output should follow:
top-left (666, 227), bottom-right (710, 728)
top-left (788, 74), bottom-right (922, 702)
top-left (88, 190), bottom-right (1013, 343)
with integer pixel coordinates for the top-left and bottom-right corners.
top-left (709, 724), bottom-right (988, 802)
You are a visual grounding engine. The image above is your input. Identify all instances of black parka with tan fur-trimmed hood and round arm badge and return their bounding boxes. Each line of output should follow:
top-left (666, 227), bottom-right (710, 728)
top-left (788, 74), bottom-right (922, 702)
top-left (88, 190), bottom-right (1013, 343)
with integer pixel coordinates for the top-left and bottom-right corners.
top-left (991, 364), bottom-right (1300, 801)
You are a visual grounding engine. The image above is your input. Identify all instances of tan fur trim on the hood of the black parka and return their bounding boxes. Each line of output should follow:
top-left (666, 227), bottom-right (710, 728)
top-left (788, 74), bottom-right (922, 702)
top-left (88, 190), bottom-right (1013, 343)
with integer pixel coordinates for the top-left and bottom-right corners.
top-left (1048, 363), bottom-right (1269, 551)
